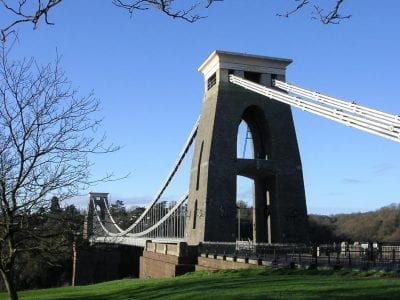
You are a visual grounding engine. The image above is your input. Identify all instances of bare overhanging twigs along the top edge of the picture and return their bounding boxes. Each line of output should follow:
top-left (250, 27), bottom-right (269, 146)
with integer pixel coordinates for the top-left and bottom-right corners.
top-left (0, 0), bottom-right (350, 41)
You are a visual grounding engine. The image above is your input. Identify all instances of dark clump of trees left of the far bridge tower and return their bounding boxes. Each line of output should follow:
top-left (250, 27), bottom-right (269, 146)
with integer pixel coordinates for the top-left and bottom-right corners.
top-left (2, 197), bottom-right (84, 290)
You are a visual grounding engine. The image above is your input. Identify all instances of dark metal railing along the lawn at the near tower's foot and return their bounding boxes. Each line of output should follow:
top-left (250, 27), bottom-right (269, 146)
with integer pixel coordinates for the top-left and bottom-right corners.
top-left (199, 242), bottom-right (400, 271)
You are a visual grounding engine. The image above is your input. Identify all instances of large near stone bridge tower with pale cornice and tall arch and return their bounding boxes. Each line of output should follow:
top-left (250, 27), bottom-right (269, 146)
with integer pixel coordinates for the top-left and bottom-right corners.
top-left (185, 51), bottom-right (307, 245)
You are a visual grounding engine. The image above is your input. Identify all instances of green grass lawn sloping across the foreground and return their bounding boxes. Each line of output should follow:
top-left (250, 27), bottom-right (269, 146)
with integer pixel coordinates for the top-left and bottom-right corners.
top-left (0, 269), bottom-right (400, 300)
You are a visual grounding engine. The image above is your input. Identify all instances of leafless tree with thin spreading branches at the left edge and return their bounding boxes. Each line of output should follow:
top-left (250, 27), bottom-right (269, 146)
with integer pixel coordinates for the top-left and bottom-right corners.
top-left (0, 45), bottom-right (118, 299)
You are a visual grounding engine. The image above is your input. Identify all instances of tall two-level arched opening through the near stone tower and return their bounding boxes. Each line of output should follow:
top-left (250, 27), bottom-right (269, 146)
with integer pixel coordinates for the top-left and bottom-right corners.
top-left (236, 105), bottom-right (272, 242)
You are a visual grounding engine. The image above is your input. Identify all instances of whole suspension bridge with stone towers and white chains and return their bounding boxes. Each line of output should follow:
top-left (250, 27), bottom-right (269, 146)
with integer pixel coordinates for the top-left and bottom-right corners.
top-left (84, 51), bottom-right (400, 276)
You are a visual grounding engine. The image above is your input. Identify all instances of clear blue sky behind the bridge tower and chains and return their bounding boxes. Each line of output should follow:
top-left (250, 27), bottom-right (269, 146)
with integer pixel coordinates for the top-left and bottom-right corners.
top-left (0, 0), bottom-right (400, 214)
